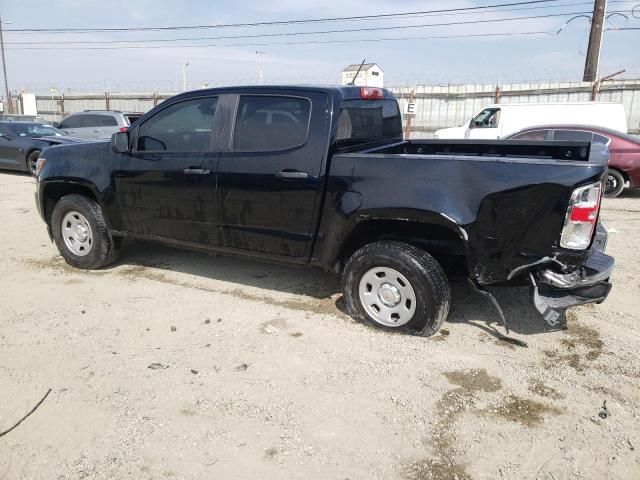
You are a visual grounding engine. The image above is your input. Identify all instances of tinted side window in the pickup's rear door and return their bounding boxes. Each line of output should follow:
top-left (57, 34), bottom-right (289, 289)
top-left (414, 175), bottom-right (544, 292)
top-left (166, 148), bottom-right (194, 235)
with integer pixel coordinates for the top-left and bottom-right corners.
top-left (233, 95), bottom-right (311, 152)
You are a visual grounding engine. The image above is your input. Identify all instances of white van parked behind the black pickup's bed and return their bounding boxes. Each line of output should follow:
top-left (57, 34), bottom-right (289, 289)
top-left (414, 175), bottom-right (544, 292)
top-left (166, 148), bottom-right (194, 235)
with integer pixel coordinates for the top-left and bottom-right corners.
top-left (435, 102), bottom-right (628, 139)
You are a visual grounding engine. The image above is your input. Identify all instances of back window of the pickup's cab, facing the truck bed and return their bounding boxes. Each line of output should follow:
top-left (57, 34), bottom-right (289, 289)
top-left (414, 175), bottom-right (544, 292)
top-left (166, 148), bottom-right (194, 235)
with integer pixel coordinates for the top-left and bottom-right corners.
top-left (335, 99), bottom-right (402, 148)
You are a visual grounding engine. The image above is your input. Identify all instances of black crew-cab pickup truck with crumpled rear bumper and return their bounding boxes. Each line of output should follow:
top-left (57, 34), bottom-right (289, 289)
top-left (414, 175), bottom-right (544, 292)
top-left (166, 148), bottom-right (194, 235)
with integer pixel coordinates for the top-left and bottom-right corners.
top-left (36, 86), bottom-right (613, 335)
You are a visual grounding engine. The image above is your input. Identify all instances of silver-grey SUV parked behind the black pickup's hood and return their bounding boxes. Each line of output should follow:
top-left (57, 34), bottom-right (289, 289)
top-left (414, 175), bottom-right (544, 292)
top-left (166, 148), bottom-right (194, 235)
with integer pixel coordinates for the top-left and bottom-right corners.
top-left (58, 110), bottom-right (142, 140)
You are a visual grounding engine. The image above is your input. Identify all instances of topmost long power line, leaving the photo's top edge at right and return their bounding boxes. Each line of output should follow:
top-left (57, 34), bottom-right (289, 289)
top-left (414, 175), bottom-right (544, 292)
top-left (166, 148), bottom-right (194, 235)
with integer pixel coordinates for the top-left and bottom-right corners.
top-left (6, 0), bottom-right (560, 33)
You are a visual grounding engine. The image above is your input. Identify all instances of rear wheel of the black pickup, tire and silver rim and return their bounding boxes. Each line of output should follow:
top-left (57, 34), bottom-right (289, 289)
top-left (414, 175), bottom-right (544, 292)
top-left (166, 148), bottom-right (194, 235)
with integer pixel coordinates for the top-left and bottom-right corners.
top-left (342, 241), bottom-right (451, 336)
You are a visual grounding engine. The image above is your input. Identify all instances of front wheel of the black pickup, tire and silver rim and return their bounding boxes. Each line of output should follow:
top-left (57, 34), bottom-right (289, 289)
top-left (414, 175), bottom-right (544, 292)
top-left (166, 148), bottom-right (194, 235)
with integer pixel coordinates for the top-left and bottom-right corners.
top-left (51, 194), bottom-right (121, 270)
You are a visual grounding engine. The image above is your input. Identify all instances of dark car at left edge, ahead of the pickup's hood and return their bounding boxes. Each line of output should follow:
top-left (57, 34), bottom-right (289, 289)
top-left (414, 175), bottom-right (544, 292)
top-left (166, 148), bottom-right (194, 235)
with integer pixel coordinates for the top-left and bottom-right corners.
top-left (0, 121), bottom-right (86, 175)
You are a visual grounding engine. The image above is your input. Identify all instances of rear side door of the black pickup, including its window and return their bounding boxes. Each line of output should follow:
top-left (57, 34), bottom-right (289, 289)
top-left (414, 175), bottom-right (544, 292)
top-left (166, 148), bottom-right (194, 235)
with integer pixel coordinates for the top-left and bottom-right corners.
top-left (218, 92), bottom-right (328, 258)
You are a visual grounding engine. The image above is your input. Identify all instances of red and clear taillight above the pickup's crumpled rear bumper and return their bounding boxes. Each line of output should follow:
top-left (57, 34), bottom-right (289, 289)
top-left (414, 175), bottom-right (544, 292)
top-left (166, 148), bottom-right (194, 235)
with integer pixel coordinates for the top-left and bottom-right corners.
top-left (560, 183), bottom-right (602, 250)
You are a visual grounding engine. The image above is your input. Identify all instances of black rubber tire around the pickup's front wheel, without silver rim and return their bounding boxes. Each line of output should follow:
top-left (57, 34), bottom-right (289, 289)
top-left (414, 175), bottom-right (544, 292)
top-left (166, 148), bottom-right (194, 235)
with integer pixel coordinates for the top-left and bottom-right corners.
top-left (51, 194), bottom-right (122, 270)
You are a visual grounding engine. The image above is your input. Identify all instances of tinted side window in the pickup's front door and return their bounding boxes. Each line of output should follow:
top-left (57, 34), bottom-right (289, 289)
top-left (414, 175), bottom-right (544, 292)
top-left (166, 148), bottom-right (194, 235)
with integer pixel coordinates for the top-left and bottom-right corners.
top-left (136, 97), bottom-right (218, 152)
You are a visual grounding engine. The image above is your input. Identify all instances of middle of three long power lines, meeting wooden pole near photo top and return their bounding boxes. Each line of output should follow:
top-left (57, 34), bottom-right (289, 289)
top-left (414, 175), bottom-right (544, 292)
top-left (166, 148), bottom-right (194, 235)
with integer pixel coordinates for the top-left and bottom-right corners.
top-left (7, 11), bottom-right (625, 50)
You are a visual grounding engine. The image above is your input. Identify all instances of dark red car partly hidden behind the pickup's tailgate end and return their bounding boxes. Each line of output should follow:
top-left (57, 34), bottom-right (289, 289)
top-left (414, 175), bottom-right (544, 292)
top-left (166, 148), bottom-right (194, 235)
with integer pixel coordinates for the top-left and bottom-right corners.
top-left (508, 125), bottom-right (640, 197)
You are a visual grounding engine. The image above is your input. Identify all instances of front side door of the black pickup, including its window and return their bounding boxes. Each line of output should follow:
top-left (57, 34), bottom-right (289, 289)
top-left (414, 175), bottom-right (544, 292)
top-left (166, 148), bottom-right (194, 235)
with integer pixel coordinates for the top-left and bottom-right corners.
top-left (115, 96), bottom-right (220, 246)
